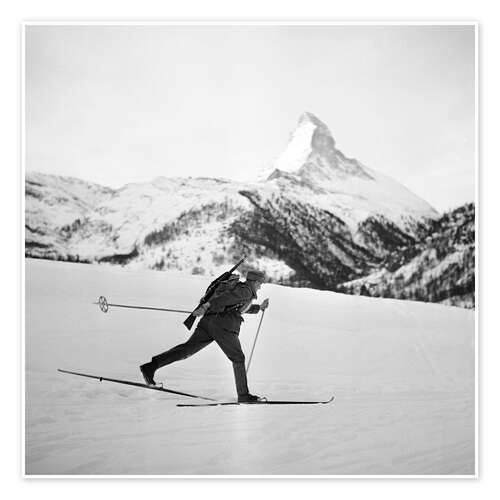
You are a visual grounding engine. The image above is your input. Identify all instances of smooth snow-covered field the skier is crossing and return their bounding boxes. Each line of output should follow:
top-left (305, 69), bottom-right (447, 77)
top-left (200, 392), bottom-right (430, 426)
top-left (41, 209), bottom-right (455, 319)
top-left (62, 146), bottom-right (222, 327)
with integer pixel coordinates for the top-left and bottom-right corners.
top-left (25, 259), bottom-right (475, 475)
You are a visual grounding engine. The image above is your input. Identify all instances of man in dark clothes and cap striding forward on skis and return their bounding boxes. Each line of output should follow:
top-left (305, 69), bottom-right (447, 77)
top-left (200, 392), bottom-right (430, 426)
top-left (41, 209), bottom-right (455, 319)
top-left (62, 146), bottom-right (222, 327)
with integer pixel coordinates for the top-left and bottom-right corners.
top-left (140, 271), bottom-right (269, 403)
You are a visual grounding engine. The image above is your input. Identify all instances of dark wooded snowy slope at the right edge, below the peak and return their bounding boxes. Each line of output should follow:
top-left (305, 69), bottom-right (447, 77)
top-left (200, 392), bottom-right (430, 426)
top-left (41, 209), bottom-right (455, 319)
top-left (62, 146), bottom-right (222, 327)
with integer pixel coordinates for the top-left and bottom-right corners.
top-left (338, 203), bottom-right (475, 308)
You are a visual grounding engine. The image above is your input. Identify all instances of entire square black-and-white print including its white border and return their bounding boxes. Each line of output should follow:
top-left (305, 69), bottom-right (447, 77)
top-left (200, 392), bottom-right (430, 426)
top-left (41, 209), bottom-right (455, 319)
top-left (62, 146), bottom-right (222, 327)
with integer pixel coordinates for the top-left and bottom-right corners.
top-left (21, 21), bottom-right (478, 478)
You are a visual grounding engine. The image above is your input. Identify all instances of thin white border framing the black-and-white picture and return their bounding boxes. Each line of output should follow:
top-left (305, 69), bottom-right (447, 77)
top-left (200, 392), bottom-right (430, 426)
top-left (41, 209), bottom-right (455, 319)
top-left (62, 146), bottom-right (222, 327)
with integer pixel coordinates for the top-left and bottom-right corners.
top-left (19, 20), bottom-right (480, 479)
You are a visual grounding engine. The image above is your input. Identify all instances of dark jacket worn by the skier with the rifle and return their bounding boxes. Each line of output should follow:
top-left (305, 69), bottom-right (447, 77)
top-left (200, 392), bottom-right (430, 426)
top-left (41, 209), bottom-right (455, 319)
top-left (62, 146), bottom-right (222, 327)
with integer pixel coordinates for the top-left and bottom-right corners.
top-left (205, 282), bottom-right (260, 333)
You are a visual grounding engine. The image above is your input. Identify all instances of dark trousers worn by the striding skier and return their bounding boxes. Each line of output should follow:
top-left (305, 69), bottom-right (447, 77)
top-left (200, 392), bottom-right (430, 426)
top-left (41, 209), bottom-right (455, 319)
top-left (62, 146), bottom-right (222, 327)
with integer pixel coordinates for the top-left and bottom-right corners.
top-left (151, 316), bottom-right (248, 396)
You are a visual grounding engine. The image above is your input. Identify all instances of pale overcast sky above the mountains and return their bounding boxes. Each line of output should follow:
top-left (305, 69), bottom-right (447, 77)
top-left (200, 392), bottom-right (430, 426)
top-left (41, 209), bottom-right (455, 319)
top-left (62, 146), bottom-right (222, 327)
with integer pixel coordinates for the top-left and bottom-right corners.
top-left (26, 26), bottom-right (474, 210)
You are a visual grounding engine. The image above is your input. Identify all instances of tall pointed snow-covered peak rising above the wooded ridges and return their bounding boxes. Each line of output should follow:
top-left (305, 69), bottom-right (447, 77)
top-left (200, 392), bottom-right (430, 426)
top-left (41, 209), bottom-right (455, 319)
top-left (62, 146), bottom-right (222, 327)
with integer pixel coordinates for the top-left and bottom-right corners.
top-left (261, 113), bottom-right (438, 234)
